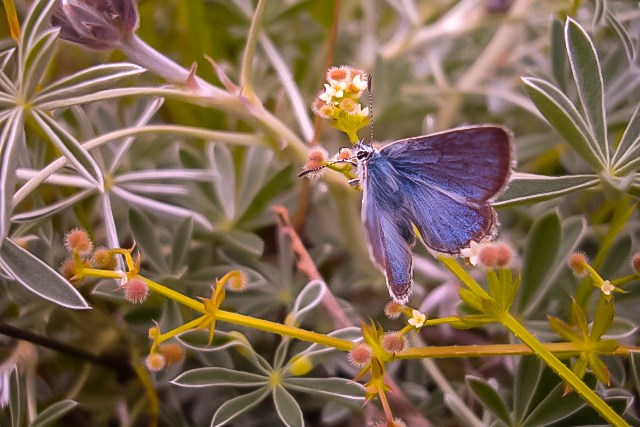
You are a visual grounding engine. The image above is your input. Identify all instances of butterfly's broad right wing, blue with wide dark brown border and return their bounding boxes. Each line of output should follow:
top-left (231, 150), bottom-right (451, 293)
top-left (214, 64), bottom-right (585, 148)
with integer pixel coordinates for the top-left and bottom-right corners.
top-left (380, 126), bottom-right (512, 254)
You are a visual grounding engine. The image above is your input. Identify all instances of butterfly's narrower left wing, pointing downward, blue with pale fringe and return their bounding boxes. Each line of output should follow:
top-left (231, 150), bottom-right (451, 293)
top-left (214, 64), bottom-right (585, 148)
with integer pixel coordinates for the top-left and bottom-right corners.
top-left (361, 159), bottom-right (415, 303)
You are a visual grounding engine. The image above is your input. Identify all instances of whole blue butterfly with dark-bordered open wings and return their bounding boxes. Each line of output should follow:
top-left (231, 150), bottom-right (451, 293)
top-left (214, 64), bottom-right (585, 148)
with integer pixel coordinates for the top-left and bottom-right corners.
top-left (301, 125), bottom-right (513, 304)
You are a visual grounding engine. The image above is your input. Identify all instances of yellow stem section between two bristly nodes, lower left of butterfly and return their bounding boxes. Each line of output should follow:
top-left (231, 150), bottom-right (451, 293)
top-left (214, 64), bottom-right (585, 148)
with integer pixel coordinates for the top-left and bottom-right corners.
top-left (216, 310), bottom-right (353, 351)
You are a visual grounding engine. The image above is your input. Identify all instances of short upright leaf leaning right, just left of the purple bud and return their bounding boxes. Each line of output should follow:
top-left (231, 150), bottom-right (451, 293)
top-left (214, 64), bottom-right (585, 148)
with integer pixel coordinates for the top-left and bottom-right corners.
top-left (21, 28), bottom-right (60, 99)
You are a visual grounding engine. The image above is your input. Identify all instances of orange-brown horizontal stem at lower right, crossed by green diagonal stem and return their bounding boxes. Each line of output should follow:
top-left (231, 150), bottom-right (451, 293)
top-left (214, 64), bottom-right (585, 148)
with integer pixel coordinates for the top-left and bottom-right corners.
top-left (395, 342), bottom-right (640, 359)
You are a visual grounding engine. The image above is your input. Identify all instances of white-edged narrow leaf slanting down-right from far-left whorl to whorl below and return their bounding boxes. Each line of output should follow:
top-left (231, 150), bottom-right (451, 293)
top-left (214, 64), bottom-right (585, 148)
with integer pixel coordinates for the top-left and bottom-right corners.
top-left (32, 110), bottom-right (104, 191)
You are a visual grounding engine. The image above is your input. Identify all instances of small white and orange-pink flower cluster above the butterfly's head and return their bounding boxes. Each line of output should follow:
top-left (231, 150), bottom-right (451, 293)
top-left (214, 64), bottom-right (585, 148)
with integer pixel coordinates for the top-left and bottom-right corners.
top-left (311, 65), bottom-right (369, 144)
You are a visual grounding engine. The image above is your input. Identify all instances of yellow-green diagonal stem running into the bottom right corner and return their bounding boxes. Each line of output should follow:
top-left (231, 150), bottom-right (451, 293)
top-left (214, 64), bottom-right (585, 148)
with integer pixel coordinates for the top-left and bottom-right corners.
top-left (499, 313), bottom-right (628, 426)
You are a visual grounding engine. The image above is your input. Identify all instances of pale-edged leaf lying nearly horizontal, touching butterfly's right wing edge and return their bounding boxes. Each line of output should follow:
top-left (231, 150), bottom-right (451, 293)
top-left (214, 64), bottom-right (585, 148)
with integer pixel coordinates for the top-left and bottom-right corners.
top-left (492, 172), bottom-right (600, 208)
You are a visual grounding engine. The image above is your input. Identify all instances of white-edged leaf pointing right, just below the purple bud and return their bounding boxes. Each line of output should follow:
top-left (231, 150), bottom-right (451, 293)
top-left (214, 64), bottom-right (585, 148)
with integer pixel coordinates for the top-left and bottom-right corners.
top-left (32, 62), bottom-right (146, 105)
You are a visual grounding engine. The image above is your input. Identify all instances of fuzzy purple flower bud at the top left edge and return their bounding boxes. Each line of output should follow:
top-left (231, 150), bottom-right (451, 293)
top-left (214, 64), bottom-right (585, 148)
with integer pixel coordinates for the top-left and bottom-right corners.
top-left (51, 0), bottom-right (138, 49)
